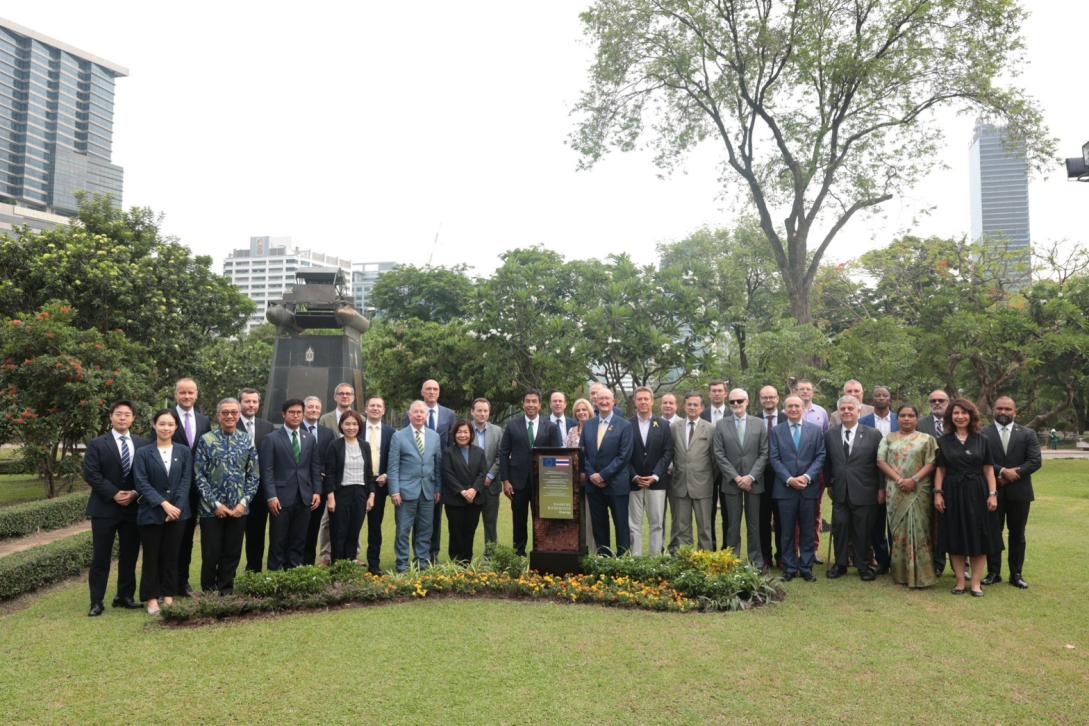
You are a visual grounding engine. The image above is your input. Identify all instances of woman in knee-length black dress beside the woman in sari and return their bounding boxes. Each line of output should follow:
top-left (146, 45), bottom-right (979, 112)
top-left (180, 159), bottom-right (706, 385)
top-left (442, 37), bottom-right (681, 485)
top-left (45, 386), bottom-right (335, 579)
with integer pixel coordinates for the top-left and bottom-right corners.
top-left (934, 398), bottom-right (999, 598)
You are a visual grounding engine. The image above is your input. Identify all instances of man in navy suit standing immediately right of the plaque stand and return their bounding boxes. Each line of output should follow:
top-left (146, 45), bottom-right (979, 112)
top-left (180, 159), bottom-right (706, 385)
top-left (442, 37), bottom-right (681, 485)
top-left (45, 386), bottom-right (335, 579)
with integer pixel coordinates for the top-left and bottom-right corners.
top-left (579, 387), bottom-right (632, 555)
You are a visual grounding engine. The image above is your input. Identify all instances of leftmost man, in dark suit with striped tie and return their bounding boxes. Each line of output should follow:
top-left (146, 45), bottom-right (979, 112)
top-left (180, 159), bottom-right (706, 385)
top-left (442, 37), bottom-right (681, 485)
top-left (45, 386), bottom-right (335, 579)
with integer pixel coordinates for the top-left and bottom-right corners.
top-left (83, 401), bottom-right (149, 617)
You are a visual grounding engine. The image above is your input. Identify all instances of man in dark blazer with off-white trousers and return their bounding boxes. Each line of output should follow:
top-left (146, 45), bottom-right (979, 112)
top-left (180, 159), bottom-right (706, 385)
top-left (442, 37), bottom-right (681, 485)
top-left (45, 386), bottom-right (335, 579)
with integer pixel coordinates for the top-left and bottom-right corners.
top-left (627, 385), bottom-right (673, 557)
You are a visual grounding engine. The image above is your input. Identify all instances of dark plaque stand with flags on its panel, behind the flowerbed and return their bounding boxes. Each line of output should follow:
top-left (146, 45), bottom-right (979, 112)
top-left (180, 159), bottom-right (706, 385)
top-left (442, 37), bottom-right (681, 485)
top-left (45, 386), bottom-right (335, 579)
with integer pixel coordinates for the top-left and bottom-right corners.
top-left (529, 447), bottom-right (586, 575)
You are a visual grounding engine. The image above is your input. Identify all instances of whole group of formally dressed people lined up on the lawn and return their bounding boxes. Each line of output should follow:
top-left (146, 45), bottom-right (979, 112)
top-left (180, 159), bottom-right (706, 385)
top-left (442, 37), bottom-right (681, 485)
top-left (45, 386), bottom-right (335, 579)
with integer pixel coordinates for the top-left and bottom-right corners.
top-left (84, 378), bottom-right (1040, 616)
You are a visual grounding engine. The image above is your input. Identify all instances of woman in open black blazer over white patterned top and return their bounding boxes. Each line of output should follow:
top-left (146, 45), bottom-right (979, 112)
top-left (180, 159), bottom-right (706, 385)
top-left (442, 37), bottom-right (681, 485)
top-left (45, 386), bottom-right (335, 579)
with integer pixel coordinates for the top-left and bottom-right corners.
top-left (325, 410), bottom-right (375, 562)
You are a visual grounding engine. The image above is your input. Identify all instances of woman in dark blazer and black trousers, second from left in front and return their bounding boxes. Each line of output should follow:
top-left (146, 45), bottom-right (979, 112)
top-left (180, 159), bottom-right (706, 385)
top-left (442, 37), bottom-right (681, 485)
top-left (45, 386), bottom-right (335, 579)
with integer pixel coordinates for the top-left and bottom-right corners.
top-left (133, 408), bottom-right (193, 615)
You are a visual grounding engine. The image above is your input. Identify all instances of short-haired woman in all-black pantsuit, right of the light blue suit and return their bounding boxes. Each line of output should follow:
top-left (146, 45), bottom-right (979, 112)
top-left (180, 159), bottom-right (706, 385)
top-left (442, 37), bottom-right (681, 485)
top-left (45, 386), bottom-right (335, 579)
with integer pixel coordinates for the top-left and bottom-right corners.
top-left (442, 420), bottom-right (488, 563)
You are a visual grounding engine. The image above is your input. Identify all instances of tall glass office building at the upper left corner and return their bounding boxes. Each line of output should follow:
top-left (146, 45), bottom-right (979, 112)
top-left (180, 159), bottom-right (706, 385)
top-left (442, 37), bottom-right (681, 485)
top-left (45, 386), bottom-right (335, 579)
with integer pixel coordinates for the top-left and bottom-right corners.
top-left (0, 19), bottom-right (129, 216)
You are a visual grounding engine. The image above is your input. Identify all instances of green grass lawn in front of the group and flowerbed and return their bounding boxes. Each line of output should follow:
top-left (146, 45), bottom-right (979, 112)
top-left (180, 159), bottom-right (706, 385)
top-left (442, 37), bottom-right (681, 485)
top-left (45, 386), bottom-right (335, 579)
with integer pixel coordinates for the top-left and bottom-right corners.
top-left (0, 462), bottom-right (1089, 724)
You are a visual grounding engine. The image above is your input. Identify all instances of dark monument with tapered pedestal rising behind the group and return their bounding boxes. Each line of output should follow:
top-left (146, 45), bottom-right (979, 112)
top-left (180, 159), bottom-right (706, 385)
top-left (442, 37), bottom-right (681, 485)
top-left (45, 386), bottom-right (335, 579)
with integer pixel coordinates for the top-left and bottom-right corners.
top-left (265, 268), bottom-right (370, 423)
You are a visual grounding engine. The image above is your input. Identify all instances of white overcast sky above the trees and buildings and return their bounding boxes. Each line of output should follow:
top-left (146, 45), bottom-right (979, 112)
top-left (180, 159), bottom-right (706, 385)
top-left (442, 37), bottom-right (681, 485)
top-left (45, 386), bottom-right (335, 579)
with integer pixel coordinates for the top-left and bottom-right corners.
top-left (8, 0), bottom-right (1089, 273)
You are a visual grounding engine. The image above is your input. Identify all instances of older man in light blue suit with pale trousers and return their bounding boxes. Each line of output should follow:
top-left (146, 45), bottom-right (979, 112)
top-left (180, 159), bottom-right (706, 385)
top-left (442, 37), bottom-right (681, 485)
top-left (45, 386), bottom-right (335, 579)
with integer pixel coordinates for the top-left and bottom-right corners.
top-left (387, 401), bottom-right (442, 573)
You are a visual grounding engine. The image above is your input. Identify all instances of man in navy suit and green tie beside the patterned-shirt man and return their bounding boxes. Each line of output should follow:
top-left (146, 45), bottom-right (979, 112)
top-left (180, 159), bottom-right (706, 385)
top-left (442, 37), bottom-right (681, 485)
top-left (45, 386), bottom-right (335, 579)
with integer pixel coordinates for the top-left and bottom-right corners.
top-left (257, 398), bottom-right (322, 570)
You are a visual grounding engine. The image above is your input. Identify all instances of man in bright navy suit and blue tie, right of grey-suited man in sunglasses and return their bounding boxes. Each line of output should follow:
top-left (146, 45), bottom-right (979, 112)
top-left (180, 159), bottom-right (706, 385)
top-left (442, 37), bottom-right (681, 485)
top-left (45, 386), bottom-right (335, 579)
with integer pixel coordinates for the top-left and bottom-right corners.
top-left (770, 394), bottom-right (824, 582)
